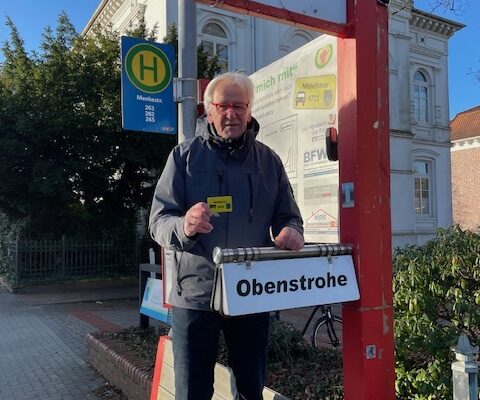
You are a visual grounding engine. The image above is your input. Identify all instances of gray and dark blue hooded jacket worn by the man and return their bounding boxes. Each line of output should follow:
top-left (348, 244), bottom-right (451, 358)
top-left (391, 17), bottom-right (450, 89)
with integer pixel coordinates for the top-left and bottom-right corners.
top-left (149, 118), bottom-right (303, 310)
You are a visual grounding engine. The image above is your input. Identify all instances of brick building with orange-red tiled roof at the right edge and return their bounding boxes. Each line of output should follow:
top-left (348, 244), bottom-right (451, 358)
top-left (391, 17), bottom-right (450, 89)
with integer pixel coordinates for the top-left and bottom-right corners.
top-left (450, 106), bottom-right (480, 232)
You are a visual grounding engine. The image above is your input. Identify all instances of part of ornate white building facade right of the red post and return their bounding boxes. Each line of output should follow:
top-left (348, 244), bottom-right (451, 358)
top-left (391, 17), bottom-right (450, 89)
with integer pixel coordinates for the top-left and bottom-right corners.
top-left (389, 1), bottom-right (463, 245)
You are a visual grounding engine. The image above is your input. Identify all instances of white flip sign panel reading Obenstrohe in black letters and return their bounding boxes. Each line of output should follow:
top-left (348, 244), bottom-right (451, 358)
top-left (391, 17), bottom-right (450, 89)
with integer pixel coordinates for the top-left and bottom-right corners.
top-left (212, 256), bottom-right (360, 316)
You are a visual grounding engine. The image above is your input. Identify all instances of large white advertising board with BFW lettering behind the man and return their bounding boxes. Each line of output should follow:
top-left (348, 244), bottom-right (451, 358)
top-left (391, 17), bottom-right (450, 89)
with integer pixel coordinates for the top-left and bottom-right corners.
top-left (250, 35), bottom-right (339, 243)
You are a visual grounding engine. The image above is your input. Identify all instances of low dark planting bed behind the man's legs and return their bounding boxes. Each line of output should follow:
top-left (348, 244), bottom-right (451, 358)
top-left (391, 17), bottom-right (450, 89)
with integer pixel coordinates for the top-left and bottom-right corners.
top-left (106, 320), bottom-right (343, 400)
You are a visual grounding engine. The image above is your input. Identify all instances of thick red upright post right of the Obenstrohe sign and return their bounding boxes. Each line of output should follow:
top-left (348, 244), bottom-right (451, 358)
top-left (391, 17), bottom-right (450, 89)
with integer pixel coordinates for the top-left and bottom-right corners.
top-left (338, 0), bottom-right (395, 400)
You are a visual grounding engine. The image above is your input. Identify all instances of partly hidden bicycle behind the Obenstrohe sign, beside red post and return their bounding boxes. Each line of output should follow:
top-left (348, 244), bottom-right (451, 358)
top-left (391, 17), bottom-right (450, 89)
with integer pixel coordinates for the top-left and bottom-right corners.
top-left (302, 305), bottom-right (342, 347)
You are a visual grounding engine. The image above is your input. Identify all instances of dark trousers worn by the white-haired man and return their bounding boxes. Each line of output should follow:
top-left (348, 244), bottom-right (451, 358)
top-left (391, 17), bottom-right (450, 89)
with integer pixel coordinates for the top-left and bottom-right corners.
top-left (172, 307), bottom-right (269, 400)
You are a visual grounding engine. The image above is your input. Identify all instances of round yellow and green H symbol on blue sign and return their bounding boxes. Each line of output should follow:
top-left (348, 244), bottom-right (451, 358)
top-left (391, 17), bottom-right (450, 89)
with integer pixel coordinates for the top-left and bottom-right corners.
top-left (125, 43), bottom-right (172, 93)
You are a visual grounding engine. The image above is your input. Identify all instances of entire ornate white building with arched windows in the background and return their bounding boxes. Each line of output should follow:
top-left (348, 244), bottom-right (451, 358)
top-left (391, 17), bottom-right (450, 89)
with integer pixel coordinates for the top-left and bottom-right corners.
top-left (83, 0), bottom-right (463, 246)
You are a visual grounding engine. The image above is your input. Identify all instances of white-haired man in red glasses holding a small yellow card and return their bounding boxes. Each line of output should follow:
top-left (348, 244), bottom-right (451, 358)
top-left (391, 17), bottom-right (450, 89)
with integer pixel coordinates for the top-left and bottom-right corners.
top-left (150, 73), bottom-right (304, 400)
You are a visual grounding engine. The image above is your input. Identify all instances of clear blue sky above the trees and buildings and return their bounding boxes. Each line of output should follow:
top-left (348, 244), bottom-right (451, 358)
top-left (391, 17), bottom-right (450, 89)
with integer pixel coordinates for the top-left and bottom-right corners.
top-left (0, 0), bottom-right (480, 118)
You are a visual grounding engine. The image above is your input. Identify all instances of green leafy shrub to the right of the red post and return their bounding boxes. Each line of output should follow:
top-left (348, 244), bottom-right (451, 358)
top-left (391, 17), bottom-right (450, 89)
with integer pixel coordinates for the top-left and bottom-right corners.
top-left (394, 227), bottom-right (480, 400)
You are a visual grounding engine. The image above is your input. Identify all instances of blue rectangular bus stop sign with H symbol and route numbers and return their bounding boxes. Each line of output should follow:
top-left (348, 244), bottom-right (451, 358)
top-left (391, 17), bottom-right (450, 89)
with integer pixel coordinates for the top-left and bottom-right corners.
top-left (121, 36), bottom-right (177, 134)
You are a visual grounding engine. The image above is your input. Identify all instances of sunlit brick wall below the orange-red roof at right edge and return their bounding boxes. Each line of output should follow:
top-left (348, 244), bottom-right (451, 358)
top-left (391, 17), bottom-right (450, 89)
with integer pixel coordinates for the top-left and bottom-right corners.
top-left (451, 147), bottom-right (480, 232)
